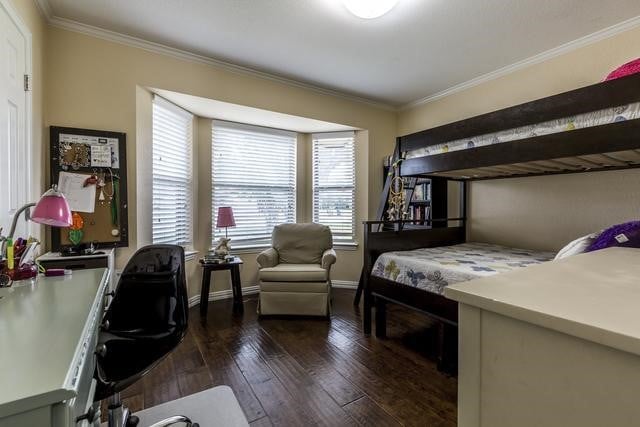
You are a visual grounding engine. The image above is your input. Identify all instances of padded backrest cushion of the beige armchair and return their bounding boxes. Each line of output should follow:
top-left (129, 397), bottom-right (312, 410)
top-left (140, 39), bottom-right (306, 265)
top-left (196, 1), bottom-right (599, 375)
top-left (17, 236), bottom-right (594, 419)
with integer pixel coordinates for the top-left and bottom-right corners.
top-left (272, 223), bottom-right (333, 264)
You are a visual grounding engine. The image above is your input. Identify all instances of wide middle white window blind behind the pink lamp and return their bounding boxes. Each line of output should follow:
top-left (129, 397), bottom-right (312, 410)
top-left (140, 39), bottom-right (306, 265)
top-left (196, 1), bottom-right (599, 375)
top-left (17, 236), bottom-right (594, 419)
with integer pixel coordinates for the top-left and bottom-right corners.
top-left (211, 120), bottom-right (296, 248)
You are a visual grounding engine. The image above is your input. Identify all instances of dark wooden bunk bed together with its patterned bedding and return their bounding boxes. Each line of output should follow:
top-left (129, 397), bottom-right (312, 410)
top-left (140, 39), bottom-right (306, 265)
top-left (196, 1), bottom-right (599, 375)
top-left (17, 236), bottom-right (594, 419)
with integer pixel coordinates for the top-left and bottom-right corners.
top-left (356, 74), bottom-right (640, 371)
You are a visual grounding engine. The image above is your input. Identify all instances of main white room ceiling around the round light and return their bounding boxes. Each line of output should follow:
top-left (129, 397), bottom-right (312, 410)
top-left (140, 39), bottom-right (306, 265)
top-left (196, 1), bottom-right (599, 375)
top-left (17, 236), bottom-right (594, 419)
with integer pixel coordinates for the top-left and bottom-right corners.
top-left (45, 0), bottom-right (640, 106)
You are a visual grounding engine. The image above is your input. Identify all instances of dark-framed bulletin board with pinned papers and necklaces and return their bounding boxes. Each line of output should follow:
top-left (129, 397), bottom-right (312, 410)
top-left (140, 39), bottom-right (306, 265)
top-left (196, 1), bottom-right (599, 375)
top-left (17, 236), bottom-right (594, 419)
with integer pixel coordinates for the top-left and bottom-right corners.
top-left (50, 126), bottom-right (129, 251)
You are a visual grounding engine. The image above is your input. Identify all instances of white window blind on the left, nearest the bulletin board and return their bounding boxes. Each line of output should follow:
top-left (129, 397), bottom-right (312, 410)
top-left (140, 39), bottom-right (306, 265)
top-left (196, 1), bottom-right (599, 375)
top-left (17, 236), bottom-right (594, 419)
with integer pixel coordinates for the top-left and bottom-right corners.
top-left (152, 96), bottom-right (193, 247)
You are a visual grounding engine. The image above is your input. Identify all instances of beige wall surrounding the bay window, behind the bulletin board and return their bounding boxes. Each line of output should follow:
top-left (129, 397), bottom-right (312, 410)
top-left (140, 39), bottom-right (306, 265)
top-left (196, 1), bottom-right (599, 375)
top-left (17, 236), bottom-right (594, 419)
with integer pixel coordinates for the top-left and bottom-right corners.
top-left (45, 27), bottom-right (397, 295)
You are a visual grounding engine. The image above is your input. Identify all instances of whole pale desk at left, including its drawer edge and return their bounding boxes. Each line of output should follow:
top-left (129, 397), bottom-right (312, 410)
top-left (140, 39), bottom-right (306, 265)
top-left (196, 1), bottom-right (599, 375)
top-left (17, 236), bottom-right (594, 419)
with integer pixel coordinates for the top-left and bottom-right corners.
top-left (0, 268), bottom-right (110, 427)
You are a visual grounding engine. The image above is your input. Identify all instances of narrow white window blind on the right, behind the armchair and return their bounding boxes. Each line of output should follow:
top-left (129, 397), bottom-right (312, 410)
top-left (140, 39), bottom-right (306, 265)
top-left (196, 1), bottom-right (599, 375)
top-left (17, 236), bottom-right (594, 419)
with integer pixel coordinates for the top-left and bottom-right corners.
top-left (313, 132), bottom-right (356, 244)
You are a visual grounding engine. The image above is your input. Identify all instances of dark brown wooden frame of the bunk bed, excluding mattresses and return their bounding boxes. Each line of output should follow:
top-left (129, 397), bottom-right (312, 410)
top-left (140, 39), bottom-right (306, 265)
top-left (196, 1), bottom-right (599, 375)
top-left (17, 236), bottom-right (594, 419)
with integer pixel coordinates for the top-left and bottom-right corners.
top-left (362, 74), bottom-right (640, 372)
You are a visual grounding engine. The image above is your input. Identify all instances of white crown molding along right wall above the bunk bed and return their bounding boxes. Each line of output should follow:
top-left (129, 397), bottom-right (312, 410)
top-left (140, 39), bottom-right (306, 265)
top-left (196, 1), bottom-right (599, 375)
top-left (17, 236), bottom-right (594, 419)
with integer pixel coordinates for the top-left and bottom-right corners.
top-left (398, 16), bottom-right (640, 111)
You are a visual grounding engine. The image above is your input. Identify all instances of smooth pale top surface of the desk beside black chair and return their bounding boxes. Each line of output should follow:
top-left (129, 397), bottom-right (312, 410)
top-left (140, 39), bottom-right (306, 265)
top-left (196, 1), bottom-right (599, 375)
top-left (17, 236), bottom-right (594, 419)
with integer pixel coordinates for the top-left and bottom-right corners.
top-left (0, 268), bottom-right (108, 417)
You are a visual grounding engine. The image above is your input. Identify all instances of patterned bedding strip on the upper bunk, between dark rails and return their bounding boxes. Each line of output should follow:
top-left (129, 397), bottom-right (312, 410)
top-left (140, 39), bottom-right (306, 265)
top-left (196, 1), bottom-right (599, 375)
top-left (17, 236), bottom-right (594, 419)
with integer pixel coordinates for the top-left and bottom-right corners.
top-left (406, 102), bottom-right (640, 159)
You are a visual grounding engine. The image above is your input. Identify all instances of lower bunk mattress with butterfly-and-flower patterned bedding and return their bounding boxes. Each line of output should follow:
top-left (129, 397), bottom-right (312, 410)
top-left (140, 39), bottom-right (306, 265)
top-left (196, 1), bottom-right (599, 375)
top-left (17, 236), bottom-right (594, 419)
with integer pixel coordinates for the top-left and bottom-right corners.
top-left (371, 243), bottom-right (555, 294)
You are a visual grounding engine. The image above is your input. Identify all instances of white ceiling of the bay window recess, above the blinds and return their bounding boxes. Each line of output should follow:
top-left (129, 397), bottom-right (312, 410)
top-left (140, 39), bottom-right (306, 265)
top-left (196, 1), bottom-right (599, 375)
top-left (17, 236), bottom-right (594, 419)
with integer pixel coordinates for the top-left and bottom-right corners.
top-left (151, 88), bottom-right (356, 133)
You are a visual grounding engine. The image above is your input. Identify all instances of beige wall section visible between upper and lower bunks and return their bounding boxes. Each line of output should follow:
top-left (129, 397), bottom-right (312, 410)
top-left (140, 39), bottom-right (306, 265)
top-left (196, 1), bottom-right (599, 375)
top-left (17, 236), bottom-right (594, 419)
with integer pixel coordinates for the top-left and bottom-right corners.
top-left (469, 169), bottom-right (640, 251)
